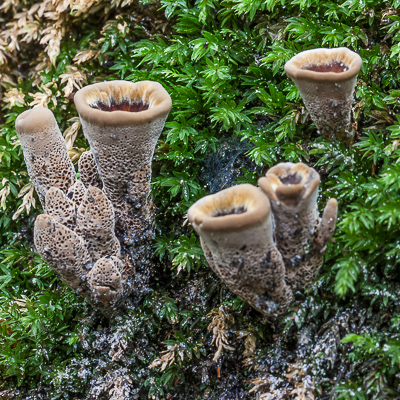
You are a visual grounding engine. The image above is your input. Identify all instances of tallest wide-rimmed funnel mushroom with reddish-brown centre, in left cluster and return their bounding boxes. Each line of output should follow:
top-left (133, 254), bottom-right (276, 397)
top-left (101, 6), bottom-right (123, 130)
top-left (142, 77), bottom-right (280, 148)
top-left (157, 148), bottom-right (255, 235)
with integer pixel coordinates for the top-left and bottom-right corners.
top-left (74, 81), bottom-right (172, 243)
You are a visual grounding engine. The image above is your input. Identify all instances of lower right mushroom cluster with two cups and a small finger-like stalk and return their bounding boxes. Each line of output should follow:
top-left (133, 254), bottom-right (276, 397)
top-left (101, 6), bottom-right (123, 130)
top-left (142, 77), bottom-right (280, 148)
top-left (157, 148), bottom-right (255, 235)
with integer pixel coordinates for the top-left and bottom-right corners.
top-left (188, 163), bottom-right (337, 318)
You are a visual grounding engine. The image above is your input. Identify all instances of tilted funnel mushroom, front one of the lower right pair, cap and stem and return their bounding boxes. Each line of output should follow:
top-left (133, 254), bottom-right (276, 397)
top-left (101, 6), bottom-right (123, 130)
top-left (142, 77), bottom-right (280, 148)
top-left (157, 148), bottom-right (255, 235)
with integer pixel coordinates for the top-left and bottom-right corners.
top-left (188, 184), bottom-right (292, 316)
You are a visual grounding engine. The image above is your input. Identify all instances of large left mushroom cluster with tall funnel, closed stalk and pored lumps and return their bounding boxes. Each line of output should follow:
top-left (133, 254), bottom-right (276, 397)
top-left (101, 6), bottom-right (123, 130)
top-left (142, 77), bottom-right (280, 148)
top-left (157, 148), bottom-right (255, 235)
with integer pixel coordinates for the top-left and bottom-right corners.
top-left (15, 81), bottom-right (172, 315)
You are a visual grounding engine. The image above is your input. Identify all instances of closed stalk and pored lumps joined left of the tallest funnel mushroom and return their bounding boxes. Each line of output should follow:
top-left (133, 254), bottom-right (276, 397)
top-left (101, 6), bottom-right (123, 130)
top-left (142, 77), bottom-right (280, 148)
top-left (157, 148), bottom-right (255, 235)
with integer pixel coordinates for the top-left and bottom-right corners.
top-left (16, 108), bottom-right (123, 316)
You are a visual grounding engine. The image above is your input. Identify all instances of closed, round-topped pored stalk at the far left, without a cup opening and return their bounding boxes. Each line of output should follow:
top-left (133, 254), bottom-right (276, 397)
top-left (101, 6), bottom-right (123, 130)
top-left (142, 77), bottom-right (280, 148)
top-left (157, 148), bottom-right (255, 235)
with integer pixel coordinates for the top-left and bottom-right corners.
top-left (15, 107), bottom-right (76, 206)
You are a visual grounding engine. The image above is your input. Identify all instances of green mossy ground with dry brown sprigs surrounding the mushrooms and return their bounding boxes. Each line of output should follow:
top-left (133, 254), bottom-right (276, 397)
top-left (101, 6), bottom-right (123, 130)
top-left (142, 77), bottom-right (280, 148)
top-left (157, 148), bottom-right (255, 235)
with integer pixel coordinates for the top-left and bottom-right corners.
top-left (0, 0), bottom-right (400, 400)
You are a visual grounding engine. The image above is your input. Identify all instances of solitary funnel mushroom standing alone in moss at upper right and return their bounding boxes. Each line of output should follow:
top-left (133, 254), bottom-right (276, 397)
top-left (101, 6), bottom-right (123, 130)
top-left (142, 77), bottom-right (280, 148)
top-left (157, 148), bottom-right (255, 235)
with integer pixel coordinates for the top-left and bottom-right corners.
top-left (285, 47), bottom-right (362, 145)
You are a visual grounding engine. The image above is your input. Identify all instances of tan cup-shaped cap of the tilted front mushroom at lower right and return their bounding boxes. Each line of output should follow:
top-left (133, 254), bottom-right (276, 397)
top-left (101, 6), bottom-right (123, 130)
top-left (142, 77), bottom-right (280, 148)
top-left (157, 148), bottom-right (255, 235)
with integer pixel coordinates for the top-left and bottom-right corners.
top-left (188, 184), bottom-right (270, 232)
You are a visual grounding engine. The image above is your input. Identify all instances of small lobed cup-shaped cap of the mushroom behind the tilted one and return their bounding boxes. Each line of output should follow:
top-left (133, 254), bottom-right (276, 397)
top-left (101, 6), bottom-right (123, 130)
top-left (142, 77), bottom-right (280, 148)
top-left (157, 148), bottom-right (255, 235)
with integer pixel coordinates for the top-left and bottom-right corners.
top-left (258, 163), bottom-right (320, 208)
